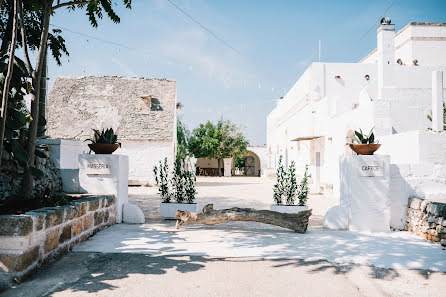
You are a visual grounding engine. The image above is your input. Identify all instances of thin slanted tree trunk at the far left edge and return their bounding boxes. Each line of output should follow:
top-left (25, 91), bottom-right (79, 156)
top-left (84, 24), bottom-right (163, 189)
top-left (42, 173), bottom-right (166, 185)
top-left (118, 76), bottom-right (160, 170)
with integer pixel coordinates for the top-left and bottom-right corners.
top-left (0, 0), bottom-right (19, 168)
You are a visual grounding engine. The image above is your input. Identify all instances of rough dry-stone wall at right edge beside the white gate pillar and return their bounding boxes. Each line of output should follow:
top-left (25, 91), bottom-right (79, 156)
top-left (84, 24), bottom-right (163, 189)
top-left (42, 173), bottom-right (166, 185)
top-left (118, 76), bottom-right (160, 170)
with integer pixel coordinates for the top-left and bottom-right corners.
top-left (406, 198), bottom-right (446, 246)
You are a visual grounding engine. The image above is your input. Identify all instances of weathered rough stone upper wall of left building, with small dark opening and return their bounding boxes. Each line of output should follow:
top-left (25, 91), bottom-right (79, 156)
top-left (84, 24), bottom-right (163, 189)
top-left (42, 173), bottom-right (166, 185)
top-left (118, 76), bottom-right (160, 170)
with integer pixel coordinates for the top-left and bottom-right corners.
top-left (47, 76), bottom-right (176, 142)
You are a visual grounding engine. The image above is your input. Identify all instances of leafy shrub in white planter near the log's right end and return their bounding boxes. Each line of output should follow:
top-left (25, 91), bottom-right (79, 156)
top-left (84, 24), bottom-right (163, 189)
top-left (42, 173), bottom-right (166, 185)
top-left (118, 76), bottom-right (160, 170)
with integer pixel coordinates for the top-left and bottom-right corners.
top-left (270, 156), bottom-right (311, 213)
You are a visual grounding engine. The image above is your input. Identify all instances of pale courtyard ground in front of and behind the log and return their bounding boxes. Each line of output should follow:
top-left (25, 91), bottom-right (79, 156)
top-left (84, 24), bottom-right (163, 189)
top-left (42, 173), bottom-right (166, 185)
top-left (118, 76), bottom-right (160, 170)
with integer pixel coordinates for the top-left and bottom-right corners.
top-left (4, 178), bottom-right (446, 297)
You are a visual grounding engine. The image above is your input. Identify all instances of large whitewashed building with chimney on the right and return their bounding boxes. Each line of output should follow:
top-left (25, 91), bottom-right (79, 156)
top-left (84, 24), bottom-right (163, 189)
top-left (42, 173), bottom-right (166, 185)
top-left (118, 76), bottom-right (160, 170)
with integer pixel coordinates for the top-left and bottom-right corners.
top-left (267, 22), bottom-right (446, 228)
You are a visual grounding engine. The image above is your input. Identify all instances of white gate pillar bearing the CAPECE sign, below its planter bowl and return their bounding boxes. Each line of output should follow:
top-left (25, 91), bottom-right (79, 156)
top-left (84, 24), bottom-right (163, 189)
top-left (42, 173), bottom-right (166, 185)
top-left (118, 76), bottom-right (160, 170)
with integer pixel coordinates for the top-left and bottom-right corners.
top-left (339, 155), bottom-right (390, 232)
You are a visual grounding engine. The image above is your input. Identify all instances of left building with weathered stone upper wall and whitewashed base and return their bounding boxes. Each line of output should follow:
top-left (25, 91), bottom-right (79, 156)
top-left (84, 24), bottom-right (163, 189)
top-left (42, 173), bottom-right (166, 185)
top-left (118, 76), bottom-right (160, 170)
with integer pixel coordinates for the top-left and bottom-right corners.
top-left (42, 76), bottom-right (177, 187)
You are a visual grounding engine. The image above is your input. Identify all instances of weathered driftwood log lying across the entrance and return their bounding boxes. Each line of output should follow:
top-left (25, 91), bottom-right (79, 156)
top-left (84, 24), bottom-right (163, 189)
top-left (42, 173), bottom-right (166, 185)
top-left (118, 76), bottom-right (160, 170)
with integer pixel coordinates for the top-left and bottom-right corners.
top-left (175, 204), bottom-right (311, 233)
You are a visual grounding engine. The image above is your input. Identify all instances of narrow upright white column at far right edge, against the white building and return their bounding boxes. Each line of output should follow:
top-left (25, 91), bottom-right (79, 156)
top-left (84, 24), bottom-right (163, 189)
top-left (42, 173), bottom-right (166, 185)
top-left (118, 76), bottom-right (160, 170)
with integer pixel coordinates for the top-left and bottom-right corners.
top-left (432, 71), bottom-right (444, 132)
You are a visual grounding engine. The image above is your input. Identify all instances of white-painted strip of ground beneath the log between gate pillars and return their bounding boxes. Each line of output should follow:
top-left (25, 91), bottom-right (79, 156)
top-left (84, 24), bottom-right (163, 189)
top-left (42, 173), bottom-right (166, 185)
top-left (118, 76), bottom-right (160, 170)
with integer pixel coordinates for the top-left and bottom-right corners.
top-left (74, 222), bottom-right (446, 271)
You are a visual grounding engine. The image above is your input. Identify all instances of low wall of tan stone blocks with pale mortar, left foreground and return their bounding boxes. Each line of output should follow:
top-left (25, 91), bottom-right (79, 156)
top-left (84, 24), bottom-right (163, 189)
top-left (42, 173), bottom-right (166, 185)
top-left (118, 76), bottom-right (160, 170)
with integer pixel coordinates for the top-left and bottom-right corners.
top-left (0, 195), bottom-right (116, 292)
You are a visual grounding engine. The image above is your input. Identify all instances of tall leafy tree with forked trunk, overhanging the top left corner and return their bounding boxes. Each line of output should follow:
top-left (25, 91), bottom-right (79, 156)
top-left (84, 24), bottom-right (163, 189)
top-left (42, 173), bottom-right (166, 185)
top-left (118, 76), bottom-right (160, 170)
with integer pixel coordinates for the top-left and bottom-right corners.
top-left (0, 0), bottom-right (131, 198)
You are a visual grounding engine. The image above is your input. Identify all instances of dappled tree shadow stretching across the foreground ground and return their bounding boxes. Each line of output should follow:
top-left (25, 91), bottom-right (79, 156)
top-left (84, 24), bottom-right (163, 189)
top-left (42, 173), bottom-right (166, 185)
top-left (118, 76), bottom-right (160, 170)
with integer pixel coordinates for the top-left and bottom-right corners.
top-left (5, 253), bottom-right (444, 297)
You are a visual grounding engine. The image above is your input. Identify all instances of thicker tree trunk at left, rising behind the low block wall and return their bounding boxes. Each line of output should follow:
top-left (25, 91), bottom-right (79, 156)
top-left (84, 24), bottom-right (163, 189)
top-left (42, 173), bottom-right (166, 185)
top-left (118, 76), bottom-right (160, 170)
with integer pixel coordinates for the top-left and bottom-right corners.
top-left (20, 0), bottom-right (53, 199)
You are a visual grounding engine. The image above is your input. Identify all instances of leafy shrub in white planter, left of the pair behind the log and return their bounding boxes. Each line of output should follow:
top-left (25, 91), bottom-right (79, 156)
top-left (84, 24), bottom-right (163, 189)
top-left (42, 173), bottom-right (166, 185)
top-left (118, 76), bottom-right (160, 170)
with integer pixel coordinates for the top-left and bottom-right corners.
top-left (153, 158), bottom-right (197, 219)
